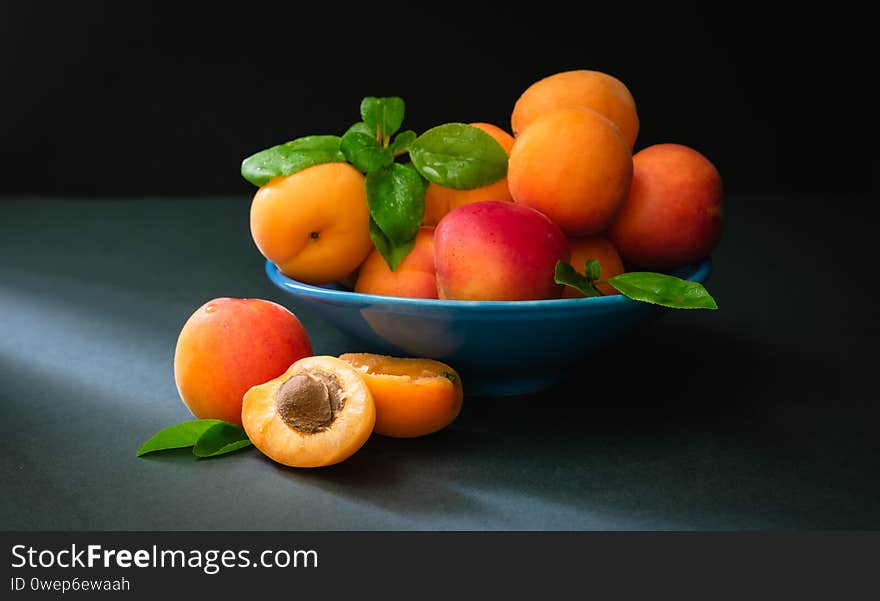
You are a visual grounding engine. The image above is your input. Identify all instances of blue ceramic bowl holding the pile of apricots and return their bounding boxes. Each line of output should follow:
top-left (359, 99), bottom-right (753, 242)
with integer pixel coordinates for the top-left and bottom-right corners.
top-left (266, 259), bottom-right (712, 395)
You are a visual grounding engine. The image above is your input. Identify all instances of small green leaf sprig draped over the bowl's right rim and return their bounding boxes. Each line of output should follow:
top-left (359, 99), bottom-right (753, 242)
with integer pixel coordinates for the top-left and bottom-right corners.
top-left (554, 259), bottom-right (718, 309)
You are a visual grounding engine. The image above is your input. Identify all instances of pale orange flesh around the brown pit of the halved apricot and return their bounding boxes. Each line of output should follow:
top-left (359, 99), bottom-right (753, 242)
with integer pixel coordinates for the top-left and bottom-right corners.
top-left (242, 356), bottom-right (376, 467)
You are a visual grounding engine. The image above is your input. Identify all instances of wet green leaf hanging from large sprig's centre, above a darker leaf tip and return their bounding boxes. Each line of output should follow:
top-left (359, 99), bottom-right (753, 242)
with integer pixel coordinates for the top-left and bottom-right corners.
top-left (366, 163), bottom-right (426, 245)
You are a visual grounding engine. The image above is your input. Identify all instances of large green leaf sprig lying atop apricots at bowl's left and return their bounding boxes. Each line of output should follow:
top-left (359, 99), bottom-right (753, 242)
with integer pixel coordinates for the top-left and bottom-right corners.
top-left (241, 96), bottom-right (508, 271)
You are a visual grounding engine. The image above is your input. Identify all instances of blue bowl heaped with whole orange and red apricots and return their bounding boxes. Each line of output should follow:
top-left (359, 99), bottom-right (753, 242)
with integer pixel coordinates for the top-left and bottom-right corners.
top-left (243, 70), bottom-right (722, 395)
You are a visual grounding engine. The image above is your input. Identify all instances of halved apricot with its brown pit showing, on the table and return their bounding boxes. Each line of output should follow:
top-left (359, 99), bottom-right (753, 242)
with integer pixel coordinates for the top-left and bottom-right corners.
top-left (241, 356), bottom-right (376, 467)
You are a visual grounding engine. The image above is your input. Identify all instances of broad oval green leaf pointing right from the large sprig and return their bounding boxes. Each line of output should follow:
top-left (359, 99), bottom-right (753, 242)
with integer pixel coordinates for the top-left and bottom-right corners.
top-left (409, 123), bottom-right (508, 190)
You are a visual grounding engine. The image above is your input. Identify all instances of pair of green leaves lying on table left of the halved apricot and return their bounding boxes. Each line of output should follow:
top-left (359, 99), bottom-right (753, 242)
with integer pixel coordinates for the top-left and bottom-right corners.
top-left (137, 419), bottom-right (251, 457)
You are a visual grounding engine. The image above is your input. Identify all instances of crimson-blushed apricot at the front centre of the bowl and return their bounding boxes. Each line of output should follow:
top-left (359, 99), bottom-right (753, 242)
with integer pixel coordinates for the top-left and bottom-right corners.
top-left (434, 201), bottom-right (569, 300)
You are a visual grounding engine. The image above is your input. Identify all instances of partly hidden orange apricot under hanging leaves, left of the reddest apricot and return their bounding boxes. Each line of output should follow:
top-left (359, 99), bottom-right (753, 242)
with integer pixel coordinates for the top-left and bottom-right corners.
top-left (354, 227), bottom-right (437, 298)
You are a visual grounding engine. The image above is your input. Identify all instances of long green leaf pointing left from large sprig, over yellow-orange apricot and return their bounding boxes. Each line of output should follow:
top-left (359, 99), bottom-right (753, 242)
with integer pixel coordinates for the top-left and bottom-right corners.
top-left (241, 136), bottom-right (345, 186)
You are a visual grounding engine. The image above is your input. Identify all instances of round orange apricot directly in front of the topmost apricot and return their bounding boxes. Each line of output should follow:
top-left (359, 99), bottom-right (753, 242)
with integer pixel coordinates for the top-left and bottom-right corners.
top-left (507, 108), bottom-right (633, 236)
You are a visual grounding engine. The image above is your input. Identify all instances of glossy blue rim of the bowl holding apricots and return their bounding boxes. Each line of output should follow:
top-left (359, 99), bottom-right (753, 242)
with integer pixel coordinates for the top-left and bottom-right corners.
top-left (266, 257), bottom-right (712, 310)
